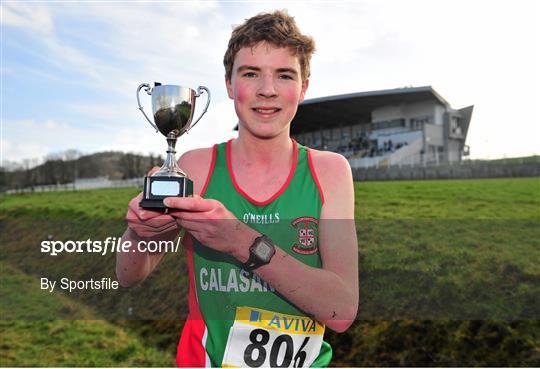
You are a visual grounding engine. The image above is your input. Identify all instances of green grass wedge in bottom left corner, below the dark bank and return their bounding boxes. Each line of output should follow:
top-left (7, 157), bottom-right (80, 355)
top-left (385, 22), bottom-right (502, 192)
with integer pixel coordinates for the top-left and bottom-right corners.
top-left (0, 263), bottom-right (174, 367)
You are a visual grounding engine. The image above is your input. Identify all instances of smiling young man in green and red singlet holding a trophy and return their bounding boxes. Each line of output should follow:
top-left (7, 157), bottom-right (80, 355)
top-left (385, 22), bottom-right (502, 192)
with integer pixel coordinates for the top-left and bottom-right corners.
top-left (117, 11), bottom-right (358, 367)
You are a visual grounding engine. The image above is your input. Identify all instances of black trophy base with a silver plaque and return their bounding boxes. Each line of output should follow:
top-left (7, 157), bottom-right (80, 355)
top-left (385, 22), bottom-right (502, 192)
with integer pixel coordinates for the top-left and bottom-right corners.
top-left (139, 176), bottom-right (193, 211)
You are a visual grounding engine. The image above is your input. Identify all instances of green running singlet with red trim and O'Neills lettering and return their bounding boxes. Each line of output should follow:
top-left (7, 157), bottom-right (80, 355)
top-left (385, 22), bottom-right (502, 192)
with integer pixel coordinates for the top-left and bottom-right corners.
top-left (176, 141), bottom-right (332, 367)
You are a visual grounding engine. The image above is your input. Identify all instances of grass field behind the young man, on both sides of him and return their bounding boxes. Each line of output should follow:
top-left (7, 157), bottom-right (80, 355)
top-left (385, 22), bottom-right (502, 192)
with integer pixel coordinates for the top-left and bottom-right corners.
top-left (0, 178), bottom-right (540, 366)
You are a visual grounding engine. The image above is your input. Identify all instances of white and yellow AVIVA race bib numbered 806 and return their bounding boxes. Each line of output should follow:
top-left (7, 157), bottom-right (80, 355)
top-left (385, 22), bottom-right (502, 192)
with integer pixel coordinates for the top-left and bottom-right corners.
top-left (221, 307), bottom-right (324, 368)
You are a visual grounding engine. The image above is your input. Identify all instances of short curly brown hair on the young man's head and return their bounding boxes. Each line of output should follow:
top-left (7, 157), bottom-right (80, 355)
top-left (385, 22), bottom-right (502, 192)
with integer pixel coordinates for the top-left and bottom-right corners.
top-left (223, 10), bottom-right (315, 81)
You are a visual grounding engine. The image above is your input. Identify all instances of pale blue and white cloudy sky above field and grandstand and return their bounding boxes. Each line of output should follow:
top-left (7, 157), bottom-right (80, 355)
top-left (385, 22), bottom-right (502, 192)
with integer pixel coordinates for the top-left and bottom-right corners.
top-left (0, 0), bottom-right (540, 165)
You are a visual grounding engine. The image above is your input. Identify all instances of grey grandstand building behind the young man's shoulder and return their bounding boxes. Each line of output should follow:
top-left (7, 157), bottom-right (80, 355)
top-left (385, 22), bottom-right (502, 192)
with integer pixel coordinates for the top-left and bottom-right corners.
top-left (291, 86), bottom-right (473, 168)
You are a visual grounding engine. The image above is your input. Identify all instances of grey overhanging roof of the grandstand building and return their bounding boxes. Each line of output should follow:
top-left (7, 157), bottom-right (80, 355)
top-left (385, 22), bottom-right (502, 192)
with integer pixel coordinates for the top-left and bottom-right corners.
top-left (291, 86), bottom-right (450, 135)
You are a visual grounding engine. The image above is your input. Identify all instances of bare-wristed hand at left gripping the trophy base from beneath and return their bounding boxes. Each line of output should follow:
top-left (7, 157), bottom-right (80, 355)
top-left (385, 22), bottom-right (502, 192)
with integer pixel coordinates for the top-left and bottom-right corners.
top-left (126, 167), bottom-right (178, 238)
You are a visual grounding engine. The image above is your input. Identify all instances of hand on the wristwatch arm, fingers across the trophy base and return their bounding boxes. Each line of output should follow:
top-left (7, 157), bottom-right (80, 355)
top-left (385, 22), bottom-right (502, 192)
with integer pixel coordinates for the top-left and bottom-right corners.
top-left (163, 195), bottom-right (260, 262)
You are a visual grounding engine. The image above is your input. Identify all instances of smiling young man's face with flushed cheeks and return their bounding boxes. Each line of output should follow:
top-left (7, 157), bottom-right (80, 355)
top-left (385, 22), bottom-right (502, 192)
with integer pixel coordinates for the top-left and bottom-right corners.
top-left (226, 42), bottom-right (308, 138)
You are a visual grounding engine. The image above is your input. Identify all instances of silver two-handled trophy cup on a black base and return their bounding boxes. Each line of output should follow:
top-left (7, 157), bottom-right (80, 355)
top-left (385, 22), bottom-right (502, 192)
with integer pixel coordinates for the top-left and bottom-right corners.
top-left (137, 82), bottom-right (210, 210)
